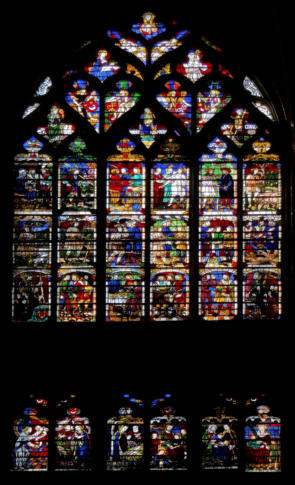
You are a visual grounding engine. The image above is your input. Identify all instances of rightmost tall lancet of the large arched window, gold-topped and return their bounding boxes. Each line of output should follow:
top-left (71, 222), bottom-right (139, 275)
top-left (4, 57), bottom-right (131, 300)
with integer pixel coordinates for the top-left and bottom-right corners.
top-left (243, 138), bottom-right (282, 319)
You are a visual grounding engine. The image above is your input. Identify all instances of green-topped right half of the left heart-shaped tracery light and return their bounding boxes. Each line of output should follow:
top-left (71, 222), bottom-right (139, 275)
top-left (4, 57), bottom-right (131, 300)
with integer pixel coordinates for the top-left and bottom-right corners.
top-left (104, 81), bottom-right (140, 131)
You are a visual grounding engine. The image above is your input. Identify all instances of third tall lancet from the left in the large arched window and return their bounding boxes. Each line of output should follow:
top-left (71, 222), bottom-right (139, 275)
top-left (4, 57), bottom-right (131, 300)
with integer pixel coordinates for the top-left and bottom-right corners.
top-left (106, 138), bottom-right (146, 322)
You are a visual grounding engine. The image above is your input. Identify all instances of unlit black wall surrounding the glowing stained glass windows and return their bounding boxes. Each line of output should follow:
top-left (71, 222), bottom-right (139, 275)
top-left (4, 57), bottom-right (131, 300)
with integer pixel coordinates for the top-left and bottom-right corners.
top-left (1, 0), bottom-right (295, 483)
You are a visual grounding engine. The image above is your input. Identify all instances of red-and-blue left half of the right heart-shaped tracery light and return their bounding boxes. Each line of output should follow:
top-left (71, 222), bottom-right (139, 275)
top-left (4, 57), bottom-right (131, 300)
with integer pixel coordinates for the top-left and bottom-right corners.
top-left (157, 81), bottom-right (192, 132)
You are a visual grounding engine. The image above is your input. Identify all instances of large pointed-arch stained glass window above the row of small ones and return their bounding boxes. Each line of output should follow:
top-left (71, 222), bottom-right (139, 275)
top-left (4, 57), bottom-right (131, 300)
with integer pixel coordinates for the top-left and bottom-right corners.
top-left (12, 12), bottom-right (283, 324)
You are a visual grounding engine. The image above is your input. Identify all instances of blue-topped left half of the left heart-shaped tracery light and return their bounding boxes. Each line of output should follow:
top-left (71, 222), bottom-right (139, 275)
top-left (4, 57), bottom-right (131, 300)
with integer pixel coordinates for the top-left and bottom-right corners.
top-left (65, 79), bottom-right (100, 133)
